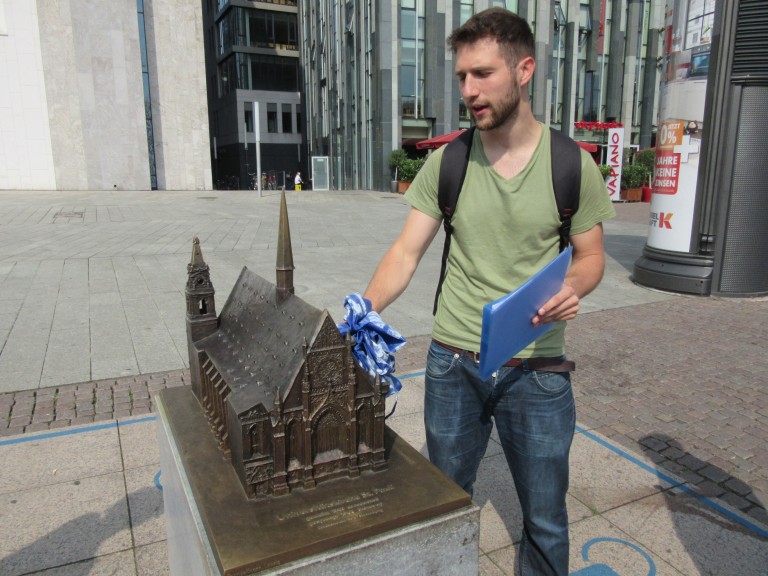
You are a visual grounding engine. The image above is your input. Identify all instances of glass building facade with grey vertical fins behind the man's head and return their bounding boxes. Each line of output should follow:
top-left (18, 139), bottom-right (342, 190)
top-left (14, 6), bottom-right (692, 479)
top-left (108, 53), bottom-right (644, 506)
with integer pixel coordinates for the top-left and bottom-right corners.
top-left (299, 0), bottom-right (664, 190)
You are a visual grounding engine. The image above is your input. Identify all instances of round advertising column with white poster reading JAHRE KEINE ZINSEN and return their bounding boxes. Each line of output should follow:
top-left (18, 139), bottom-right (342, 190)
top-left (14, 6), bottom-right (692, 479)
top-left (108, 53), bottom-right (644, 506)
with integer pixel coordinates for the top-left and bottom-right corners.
top-left (633, 0), bottom-right (715, 294)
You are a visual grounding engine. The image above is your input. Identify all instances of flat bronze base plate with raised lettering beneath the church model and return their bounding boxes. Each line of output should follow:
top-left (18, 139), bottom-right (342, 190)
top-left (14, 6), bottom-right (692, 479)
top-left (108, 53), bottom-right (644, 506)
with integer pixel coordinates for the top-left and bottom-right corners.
top-left (160, 388), bottom-right (471, 575)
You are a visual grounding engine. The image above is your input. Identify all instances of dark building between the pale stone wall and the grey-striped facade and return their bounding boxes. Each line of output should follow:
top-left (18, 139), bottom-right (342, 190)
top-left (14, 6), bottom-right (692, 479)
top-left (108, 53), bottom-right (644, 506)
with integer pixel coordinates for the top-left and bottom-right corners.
top-left (203, 0), bottom-right (307, 189)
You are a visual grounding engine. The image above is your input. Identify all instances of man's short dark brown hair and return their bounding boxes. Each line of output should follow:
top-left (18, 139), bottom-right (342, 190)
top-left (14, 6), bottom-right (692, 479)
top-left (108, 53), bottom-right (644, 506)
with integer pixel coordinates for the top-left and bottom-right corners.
top-left (447, 8), bottom-right (536, 67)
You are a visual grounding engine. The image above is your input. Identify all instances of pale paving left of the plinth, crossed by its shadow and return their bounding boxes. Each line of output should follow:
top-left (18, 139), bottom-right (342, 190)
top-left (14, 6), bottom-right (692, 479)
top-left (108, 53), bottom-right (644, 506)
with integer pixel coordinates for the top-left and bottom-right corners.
top-left (0, 417), bottom-right (162, 576)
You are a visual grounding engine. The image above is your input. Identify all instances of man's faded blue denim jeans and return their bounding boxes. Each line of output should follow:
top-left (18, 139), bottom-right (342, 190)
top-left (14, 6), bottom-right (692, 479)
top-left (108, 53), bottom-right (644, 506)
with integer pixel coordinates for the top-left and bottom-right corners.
top-left (424, 342), bottom-right (576, 576)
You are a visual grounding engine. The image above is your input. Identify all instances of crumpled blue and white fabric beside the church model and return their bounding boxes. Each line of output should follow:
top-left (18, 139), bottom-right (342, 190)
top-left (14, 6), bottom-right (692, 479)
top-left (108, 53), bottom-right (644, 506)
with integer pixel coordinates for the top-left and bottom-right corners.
top-left (338, 293), bottom-right (405, 410)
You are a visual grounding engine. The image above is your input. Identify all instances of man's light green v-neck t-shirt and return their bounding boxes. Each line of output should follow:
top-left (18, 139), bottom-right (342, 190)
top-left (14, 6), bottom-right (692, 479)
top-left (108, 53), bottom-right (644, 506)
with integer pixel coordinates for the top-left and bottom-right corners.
top-left (405, 127), bottom-right (615, 358)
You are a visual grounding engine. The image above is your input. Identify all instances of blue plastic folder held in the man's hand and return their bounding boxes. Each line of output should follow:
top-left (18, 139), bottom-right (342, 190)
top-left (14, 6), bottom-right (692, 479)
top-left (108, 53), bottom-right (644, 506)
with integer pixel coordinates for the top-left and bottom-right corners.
top-left (479, 246), bottom-right (573, 380)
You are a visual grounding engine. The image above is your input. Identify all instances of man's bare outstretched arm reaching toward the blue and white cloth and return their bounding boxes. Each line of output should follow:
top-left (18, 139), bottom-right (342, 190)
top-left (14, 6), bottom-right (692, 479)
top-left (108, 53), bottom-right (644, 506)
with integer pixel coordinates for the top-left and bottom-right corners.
top-left (363, 208), bottom-right (440, 313)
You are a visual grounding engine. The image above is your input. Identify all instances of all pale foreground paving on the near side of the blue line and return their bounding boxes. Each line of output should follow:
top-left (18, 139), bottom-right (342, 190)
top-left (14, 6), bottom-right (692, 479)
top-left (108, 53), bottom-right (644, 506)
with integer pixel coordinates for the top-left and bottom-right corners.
top-left (0, 390), bottom-right (768, 576)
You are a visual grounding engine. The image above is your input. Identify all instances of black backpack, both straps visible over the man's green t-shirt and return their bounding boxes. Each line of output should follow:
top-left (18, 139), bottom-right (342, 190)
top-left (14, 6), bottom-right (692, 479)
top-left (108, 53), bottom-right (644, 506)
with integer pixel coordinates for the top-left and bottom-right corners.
top-left (432, 127), bottom-right (581, 315)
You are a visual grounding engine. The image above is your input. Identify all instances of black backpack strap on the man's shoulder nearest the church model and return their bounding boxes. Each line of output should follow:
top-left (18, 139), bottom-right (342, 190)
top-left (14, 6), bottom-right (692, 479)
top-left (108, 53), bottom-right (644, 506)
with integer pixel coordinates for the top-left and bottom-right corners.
top-left (432, 126), bottom-right (475, 315)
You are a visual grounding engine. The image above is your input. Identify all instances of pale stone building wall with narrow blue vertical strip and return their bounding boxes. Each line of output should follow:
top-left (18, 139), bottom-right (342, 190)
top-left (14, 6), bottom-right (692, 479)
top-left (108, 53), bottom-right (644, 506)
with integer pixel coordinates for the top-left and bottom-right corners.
top-left (0, 0), bottom-right (212, 190)
